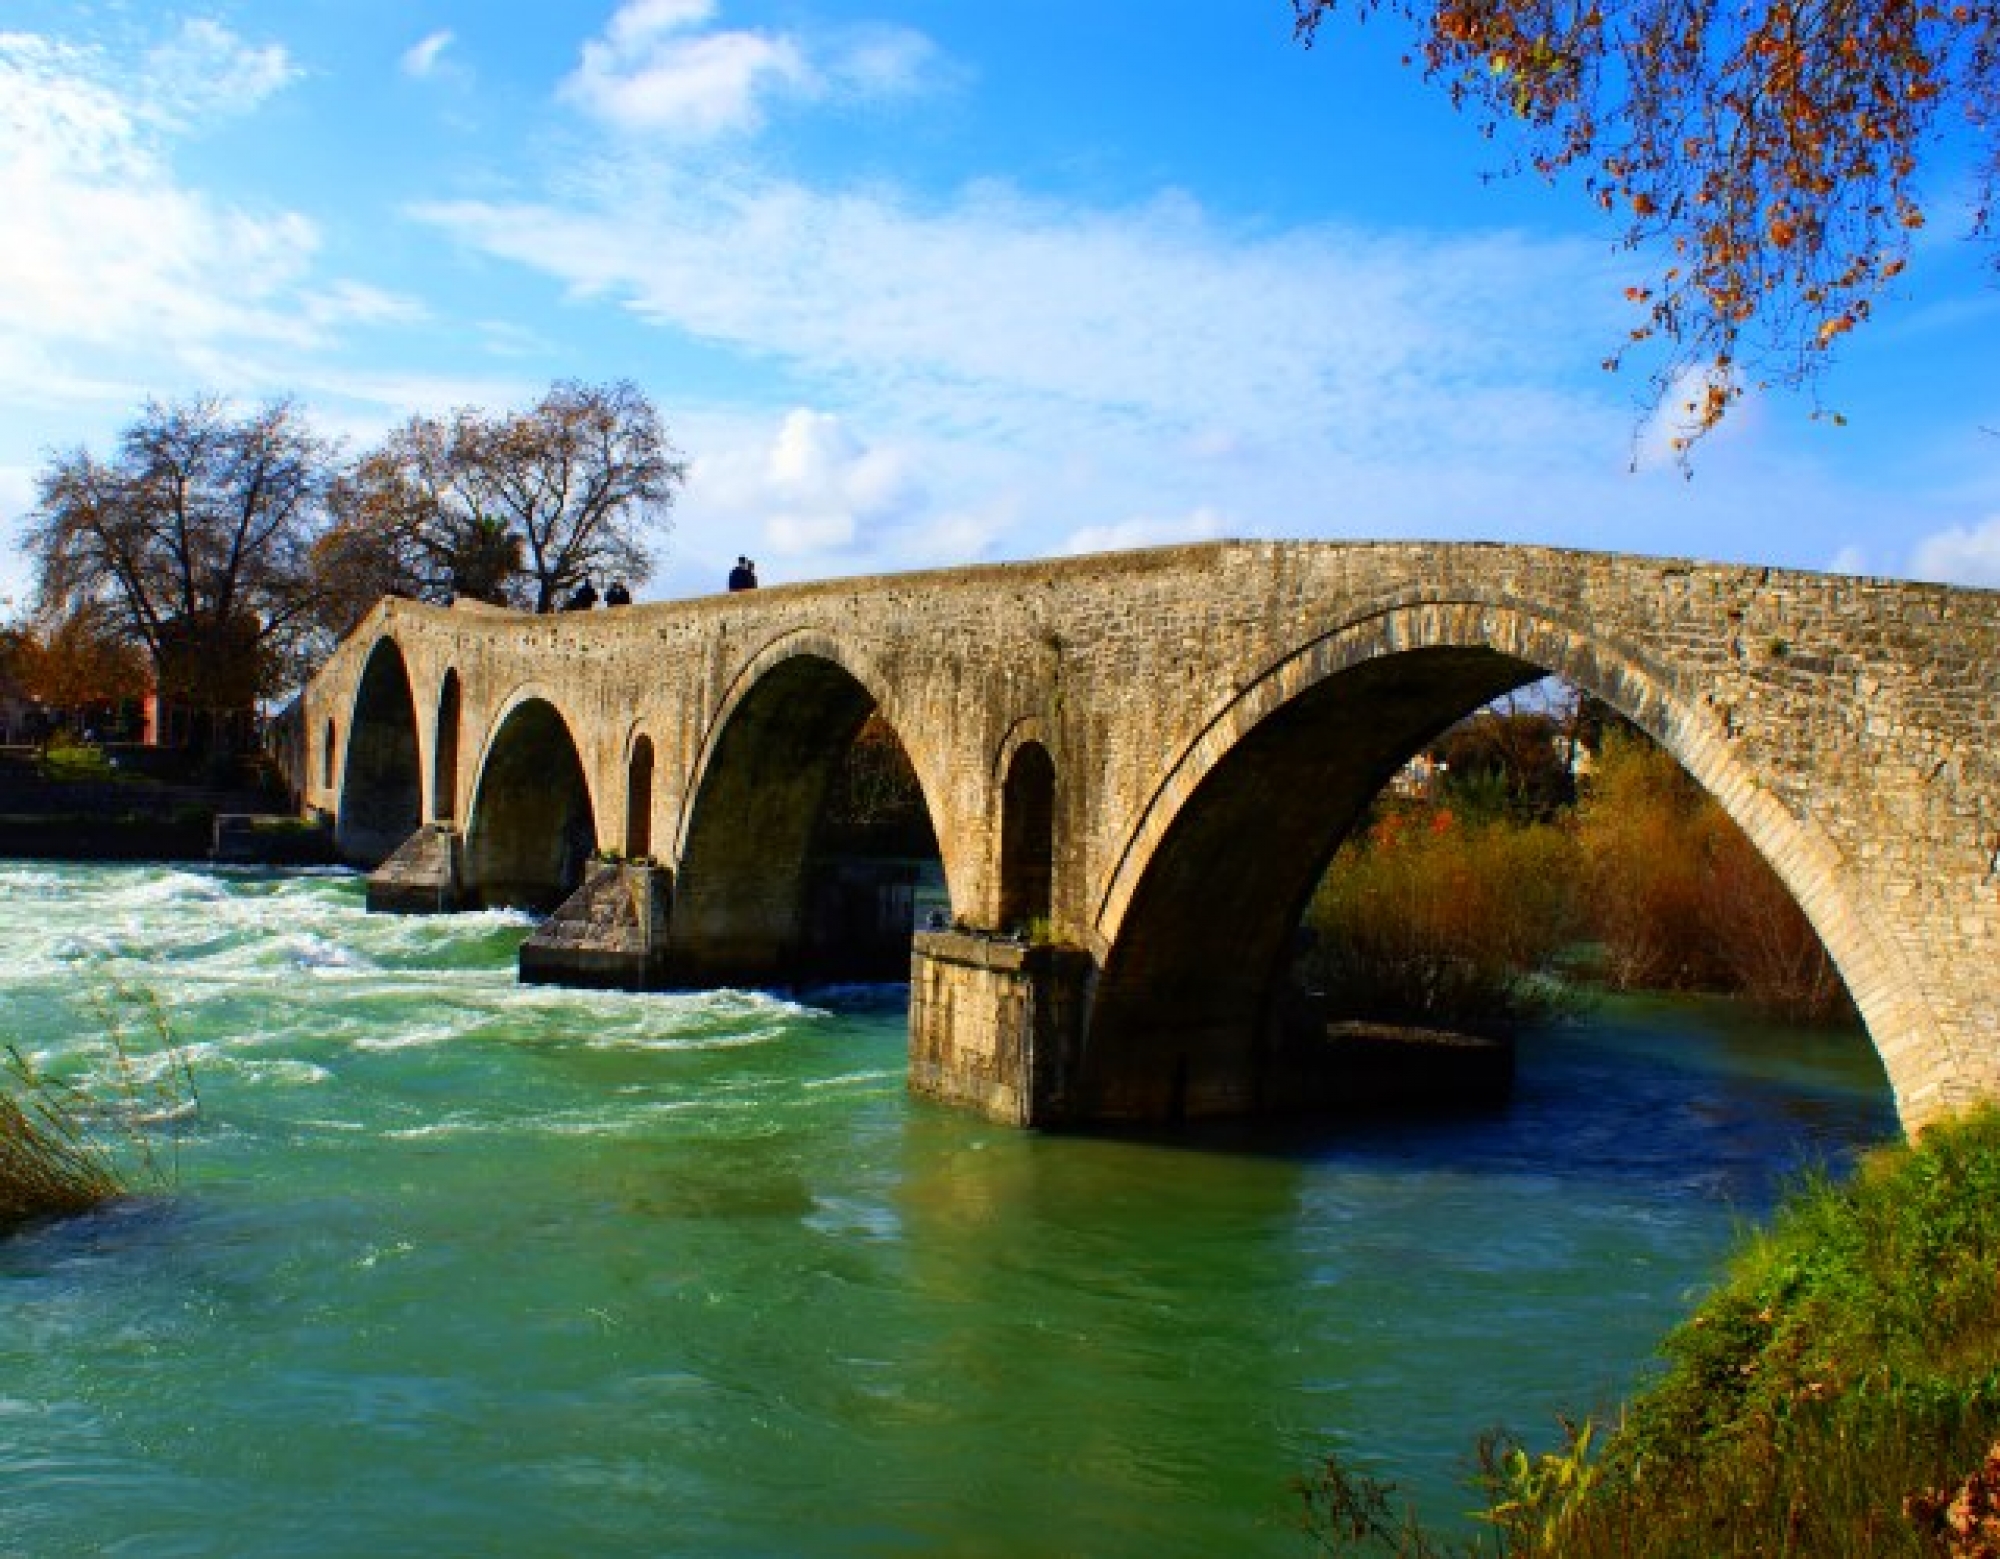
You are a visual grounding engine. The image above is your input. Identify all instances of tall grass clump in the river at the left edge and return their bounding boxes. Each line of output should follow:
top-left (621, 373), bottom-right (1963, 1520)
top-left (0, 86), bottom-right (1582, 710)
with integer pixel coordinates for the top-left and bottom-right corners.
top-left (0, 983), bottom-right (196, 1235)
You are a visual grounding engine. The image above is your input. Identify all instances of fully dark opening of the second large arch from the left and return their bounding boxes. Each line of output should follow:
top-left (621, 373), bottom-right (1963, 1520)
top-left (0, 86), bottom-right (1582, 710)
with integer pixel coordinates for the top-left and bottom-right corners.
top-left (464, 696), bottom-right (598, 909)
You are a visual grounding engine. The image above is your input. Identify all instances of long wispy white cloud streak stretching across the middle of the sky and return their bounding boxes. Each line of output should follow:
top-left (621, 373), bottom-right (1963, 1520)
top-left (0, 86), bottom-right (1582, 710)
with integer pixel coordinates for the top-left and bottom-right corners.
top-left (418, 166), bottom-right (1612, 465)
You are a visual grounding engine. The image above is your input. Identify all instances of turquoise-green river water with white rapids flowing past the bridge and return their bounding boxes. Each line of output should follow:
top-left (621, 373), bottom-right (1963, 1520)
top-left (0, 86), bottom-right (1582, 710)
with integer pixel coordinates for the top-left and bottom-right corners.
top-left (0, 863), bottom-right (1894, 1559)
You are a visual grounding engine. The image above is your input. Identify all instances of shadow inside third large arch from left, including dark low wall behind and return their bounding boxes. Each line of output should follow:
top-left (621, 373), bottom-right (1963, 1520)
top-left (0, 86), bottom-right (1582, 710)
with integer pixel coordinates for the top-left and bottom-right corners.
top-left (672, 632), bottom-right (938, 985)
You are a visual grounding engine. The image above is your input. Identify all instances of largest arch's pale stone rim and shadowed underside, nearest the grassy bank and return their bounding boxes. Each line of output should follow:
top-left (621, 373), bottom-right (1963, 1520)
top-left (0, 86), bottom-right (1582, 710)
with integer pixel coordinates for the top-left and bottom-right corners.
top-left (1066, 600), bottom-right (1934, 1119)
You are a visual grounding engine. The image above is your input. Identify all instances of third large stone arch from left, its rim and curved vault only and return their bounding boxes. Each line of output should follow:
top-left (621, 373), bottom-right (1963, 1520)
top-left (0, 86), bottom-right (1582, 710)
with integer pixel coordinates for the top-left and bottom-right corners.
top-left (672, 632), bottom-right (950, 985)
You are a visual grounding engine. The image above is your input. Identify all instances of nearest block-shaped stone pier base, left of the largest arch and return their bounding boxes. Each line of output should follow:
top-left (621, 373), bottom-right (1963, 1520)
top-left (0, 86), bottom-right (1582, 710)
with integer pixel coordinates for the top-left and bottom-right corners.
top-left (910, 931), bottom-right (1092, 1125)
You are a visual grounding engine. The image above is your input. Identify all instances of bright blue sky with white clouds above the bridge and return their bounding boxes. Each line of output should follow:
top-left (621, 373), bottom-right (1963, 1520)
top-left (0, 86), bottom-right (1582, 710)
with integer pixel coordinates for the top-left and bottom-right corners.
top-left (0, 0), bottom-right (2000, 600)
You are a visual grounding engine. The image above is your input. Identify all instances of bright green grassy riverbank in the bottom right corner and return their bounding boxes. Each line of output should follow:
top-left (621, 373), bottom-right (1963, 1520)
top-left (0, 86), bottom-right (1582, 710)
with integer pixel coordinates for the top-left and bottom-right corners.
top-left (1304, 1109), bottom-right (2000, 1559)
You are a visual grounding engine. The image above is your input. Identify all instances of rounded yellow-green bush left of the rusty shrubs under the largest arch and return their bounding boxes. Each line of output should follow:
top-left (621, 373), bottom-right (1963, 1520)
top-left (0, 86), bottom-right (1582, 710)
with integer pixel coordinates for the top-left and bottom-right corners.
top-left (1306, 807), bottom-right (1576, 1031)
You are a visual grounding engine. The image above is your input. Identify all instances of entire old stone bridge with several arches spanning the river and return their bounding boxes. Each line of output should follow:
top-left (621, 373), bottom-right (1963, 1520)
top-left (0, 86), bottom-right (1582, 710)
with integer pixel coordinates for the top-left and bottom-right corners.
top-left (286, 542), bottom-right (2000, 1127)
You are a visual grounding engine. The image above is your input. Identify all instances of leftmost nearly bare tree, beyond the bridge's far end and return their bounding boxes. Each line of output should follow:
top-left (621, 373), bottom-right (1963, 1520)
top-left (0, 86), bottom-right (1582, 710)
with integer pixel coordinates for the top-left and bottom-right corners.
top-left (24, 396), bottom-right (332, 738)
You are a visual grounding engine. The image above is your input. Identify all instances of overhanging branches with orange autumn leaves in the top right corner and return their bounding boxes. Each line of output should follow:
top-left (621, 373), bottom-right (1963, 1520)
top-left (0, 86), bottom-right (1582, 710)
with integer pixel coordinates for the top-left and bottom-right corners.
top-left (1292, 0), bottom-right (2000, 448)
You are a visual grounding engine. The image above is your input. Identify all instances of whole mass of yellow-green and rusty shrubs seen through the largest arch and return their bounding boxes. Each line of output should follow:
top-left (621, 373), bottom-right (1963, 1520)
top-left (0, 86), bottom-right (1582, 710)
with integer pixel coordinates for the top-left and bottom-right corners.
top-left (1304, 732), bottom-right (1854, 1031)
